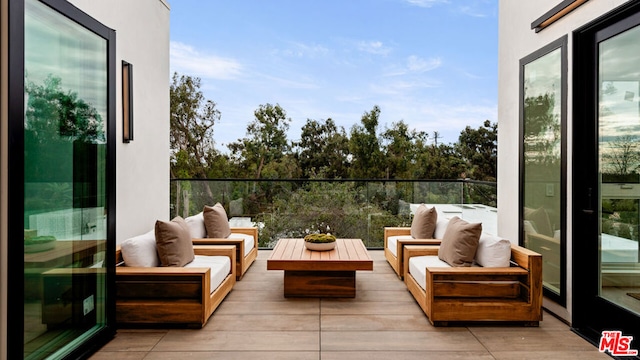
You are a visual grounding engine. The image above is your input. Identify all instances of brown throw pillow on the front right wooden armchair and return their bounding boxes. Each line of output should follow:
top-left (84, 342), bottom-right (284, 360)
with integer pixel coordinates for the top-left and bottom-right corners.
top-left (438, 216), bottom-right (482, 266)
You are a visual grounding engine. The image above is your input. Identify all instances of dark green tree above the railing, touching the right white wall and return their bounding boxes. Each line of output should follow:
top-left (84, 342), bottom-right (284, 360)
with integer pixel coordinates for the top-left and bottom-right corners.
top-left (456, 120), bottom-right (498, 181)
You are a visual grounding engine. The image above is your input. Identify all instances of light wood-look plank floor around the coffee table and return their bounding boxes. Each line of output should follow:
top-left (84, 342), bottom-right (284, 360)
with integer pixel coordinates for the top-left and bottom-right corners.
top-left (91, 251), bottom-right (609, 360)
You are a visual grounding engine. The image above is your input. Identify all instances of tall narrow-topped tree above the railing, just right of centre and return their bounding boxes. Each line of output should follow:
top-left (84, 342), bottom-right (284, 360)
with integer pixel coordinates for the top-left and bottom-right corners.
top-left (349, 105), bottom-right (384, 179)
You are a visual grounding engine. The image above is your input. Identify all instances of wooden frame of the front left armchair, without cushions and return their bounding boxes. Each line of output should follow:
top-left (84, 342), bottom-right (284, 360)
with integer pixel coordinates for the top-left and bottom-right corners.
top-left (116, 245), bottom-right (236, 328)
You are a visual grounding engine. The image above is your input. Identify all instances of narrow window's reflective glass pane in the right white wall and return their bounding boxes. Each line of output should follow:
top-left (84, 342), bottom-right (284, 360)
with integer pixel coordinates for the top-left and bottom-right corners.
top-left (522, 48), bottom-right (563, 295)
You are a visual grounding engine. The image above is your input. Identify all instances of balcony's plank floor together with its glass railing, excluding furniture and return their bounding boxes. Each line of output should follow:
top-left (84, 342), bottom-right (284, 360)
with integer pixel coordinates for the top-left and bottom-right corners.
top-left (87, 180), bottom-right (608, 360)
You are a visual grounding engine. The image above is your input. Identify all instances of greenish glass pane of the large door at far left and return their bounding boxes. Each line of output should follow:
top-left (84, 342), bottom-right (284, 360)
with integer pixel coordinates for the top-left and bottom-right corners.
top-left (24, 0), bottom-right (107, 359)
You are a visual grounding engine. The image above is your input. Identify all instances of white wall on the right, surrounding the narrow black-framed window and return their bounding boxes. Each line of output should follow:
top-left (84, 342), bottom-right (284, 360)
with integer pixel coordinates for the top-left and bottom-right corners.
top-left (498, 0), bottom-right (626, 321)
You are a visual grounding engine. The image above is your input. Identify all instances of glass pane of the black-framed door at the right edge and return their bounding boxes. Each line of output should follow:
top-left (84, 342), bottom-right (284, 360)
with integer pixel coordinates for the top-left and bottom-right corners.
top-left (598, 27), bottom-right (640, 314)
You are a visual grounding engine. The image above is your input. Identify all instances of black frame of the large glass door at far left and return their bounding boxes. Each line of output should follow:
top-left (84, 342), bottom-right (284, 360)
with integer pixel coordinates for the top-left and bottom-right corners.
top-left (6, 0), bottom-right (116, 359)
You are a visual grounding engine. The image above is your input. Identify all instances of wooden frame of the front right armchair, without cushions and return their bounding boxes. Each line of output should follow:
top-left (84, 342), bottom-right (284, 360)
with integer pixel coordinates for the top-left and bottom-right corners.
top-left (404, 244), bottom-right (542, 326)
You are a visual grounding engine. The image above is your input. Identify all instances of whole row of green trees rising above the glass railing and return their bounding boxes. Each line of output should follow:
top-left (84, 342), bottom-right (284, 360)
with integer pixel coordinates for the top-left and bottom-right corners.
top-left (170, 73), bottom-right (497, 181)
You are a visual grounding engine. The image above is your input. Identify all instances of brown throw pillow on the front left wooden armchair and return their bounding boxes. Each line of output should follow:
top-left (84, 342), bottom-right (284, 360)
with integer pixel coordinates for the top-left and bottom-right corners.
top-left (155, 216), bottom-right (195, 266)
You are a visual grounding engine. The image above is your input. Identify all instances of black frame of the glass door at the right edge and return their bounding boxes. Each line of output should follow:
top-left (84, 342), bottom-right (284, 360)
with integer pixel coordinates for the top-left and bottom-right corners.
top-left (571, 1), bottom-right (640, 349)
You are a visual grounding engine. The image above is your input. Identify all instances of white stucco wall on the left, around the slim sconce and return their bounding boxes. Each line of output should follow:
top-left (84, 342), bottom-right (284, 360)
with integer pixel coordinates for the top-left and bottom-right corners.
top-left (70, 0), bottom-right (170, 243)
